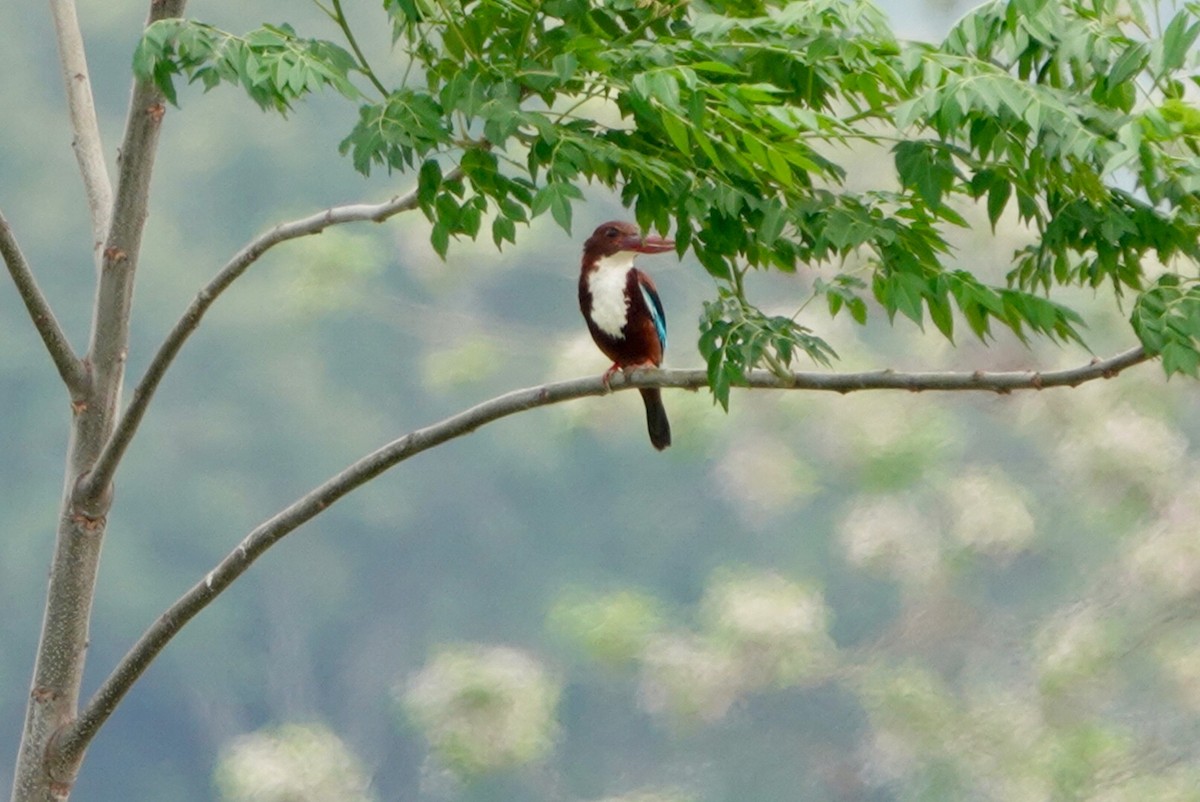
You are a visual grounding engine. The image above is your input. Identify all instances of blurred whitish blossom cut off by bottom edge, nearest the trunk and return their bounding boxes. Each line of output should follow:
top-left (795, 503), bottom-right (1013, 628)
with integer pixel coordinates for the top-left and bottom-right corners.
top-left (216, 724), bottom-right (371, 802)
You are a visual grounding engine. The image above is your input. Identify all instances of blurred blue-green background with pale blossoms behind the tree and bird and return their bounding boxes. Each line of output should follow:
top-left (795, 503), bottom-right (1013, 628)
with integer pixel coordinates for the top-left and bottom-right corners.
top-left (0, 0), bottom-right (1200, 802)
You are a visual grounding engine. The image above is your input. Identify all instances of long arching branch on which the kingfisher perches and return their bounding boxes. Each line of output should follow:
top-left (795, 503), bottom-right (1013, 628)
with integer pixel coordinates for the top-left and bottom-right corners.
top-left (56, 346), bottom-right (1151, 755)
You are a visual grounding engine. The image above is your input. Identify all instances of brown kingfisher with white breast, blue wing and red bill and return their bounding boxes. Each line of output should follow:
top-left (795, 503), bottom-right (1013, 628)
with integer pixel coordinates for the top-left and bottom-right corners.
top-left (580, 221), bottom-right (674, 451)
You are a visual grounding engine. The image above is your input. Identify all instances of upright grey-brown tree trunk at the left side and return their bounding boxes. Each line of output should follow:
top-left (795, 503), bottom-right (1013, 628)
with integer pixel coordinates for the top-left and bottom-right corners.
top-left (12, 0), bottom-right (186, 802)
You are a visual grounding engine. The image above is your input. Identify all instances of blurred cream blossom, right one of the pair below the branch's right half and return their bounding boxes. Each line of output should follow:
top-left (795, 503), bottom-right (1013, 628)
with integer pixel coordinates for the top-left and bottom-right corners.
top-left (946, 469), bottom-right (1034, 556)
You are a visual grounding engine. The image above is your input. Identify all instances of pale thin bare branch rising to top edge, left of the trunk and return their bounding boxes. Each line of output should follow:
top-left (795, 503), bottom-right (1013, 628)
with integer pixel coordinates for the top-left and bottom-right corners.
top-left (50, 0), bottom-right (113, 261)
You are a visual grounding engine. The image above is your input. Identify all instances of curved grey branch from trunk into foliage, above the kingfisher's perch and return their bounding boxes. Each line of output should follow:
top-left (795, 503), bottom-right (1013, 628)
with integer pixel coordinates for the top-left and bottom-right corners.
top-left (85, 169), bottom-right (462, 493)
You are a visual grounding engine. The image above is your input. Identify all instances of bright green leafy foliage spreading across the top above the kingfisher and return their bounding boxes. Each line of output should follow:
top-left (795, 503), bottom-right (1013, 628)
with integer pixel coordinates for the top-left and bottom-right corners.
top-left (134, 0), bottom-right (1200, 405)
